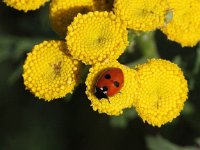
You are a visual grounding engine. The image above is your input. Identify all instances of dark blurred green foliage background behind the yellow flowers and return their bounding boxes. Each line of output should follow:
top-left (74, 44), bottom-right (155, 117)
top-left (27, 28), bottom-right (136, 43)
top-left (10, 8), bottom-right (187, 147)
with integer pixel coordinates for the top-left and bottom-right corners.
top-left (0, 2), bottom-right (200, 150)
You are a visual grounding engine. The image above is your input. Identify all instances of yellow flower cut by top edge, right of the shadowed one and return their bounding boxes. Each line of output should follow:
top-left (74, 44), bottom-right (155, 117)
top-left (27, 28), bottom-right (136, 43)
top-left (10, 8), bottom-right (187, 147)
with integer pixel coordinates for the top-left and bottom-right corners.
top-left (114, 0), bottom-right (168, 31)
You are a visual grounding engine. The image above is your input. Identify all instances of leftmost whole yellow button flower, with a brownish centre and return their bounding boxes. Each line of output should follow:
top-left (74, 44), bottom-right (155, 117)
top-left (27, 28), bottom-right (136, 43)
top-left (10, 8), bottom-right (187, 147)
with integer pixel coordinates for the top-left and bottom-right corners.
top-left (23, 40), bottom-right (81, 101)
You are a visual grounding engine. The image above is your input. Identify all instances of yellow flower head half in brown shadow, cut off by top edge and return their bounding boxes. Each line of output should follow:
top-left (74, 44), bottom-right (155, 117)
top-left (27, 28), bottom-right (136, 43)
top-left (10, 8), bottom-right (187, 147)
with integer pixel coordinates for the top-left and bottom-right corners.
top-left (49, 0), bottom-right (94, 37)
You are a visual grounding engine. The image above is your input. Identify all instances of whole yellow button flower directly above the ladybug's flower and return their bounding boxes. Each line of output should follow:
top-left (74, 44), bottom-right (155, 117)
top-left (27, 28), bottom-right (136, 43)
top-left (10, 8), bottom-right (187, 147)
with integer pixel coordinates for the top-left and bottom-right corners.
top-left (66, 11), bottom-right (128, 64)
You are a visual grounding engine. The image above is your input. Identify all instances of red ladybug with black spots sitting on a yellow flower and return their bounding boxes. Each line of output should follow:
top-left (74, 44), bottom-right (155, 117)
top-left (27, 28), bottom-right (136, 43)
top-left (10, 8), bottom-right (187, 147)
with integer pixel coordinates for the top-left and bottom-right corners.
top-left (95, 68), bottom-right (124, 99)
